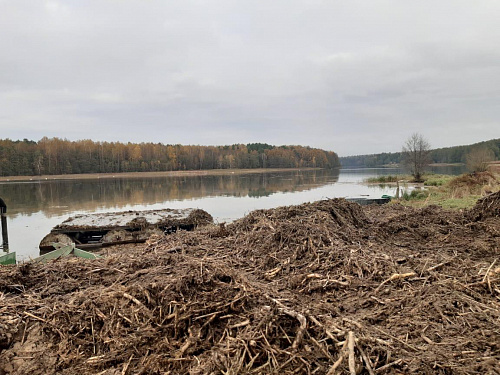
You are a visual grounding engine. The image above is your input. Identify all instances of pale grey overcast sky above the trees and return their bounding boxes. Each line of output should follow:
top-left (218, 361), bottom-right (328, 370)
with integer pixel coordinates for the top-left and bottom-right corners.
top-left (0, 0), bottom-right (500, 156)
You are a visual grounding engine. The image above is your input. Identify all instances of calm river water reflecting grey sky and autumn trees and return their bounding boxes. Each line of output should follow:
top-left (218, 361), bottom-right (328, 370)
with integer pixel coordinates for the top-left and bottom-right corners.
top-left (0, 168), bottom-right (462, 261)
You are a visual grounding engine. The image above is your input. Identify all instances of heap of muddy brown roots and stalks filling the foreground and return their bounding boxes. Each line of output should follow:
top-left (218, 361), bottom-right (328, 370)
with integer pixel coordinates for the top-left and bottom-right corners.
top-left (0, 193), bottom-right (500, 375)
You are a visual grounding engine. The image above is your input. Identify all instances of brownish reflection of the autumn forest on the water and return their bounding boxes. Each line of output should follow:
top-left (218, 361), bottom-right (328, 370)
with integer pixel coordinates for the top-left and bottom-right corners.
top-left (0, 170), bottom-right (339, 217)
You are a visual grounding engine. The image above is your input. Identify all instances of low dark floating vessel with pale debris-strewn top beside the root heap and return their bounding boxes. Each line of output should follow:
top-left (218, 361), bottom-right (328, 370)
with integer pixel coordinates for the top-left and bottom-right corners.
top-left (39, 208), bottom-right (213, 253)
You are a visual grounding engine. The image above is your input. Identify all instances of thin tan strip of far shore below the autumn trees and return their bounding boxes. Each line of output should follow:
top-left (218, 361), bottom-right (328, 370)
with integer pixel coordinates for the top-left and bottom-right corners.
top-left (0, 168), bottom-right (322, 182)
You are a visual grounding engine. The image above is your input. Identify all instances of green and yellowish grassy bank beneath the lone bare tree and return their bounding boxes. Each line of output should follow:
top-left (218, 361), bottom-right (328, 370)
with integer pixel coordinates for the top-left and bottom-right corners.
top-left (393, 172), bottom-right (500, 209)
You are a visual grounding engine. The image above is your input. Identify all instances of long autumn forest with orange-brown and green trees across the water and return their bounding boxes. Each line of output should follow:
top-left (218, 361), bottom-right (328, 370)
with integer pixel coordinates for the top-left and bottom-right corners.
top-left (0, 137), bottom-right (340, 176)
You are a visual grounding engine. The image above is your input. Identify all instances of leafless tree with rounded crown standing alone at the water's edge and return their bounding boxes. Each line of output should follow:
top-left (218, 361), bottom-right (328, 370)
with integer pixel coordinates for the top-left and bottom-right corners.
top-left (401, 133), bottom-right (431, 182)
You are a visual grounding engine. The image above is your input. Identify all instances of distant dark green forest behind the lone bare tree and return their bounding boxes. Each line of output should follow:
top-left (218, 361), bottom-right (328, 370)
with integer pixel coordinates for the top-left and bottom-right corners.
top-left (339, 138), bottom-right (500, 168)
